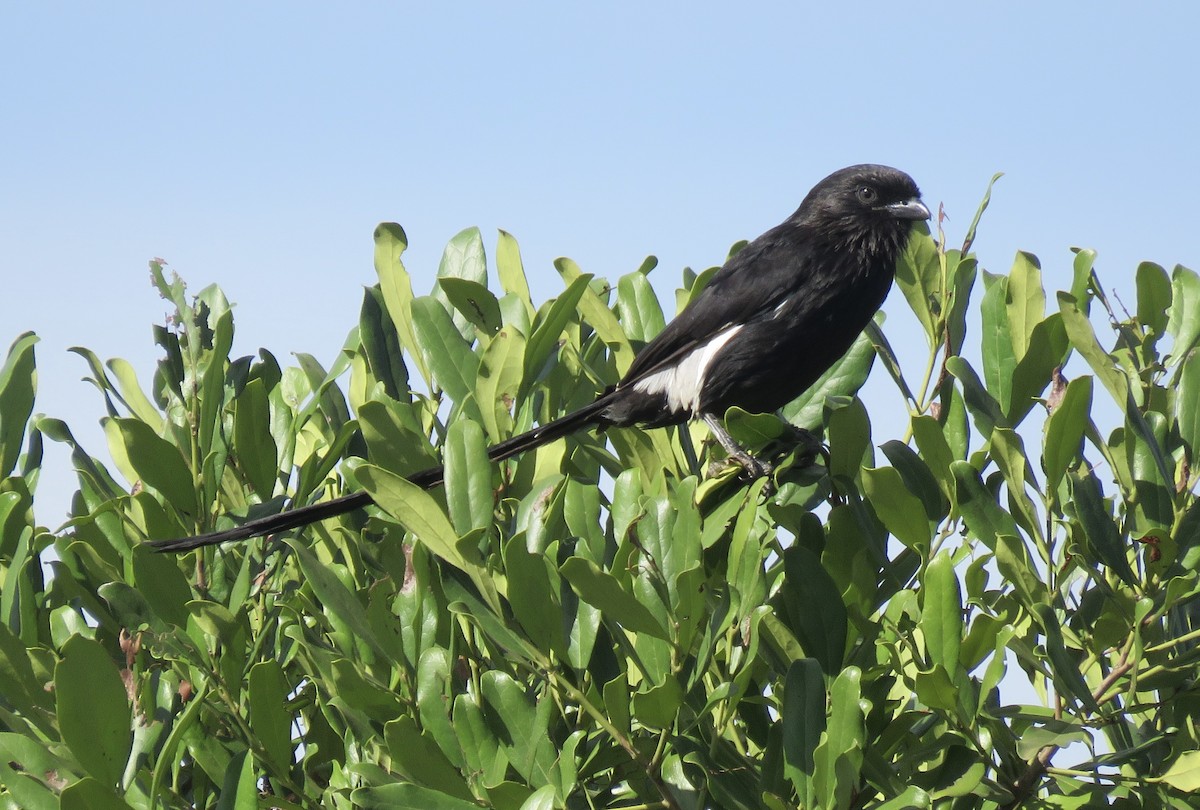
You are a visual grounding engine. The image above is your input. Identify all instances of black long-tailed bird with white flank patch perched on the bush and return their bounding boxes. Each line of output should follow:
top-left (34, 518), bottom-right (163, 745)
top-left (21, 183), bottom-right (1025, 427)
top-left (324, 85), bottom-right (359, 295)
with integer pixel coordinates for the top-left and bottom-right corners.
top-left (151, 164), bottom-right (929, 551)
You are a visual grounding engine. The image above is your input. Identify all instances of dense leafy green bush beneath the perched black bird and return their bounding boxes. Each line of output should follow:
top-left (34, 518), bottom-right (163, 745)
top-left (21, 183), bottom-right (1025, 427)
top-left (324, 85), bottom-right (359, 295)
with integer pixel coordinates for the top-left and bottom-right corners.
top-left (0, 188), bottom-right (1200, 810)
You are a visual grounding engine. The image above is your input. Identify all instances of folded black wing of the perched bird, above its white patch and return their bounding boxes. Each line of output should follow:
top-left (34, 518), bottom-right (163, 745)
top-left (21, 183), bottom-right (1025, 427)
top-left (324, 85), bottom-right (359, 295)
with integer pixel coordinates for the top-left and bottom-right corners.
top-left (618, 226), bottom-right (808, 388)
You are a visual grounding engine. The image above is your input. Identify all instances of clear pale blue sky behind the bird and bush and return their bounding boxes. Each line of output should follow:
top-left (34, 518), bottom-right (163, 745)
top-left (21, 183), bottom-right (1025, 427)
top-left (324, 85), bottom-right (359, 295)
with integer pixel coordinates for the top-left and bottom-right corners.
top-left (0, 2), bottom-right (1200, 526)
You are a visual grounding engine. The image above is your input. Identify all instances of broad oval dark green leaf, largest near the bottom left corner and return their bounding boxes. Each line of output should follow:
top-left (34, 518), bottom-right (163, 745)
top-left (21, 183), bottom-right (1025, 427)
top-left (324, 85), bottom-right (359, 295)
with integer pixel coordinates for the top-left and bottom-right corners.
top-left (54, 636), bottom-right (133, 786)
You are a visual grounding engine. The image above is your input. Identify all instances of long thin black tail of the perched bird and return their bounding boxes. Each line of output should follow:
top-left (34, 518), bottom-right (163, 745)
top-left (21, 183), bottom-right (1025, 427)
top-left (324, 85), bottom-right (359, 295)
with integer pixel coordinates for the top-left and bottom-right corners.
top-left (149, 394), bottom-right (611, 552)
